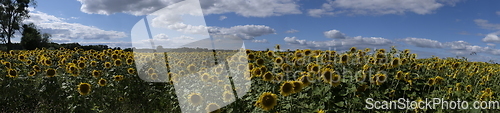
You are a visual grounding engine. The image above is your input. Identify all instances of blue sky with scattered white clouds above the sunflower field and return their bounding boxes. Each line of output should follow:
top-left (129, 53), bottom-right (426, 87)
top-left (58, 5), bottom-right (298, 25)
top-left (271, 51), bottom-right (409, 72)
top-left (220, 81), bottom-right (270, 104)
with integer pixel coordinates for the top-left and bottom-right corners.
top-left (14, 0), bottom-right (500, 62)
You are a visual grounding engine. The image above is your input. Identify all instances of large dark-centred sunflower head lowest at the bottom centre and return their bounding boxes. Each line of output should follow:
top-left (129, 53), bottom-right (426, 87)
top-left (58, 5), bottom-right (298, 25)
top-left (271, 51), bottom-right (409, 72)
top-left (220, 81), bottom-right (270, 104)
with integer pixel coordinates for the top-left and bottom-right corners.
top-left (255, 92), bottom-right (278, 111)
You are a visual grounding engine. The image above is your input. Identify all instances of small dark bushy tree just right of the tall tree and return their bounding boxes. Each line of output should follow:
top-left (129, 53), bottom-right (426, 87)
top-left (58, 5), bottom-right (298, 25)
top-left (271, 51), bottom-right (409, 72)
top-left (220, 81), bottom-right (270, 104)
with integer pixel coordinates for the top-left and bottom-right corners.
top-left (21, 23), bottom-right (51, 50)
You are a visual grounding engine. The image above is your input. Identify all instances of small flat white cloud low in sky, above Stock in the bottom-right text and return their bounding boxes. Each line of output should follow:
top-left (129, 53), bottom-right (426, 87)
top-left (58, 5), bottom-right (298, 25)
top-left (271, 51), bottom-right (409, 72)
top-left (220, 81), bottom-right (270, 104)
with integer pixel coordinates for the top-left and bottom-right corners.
top-left (400, 37), bottom-right (443, 48)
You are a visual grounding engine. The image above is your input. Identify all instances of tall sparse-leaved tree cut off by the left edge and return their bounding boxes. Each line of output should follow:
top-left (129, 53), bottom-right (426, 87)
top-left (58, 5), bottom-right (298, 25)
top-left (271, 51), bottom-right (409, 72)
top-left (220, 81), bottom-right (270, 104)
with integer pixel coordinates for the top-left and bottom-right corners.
top-left (0, 0), bottom-right (36, 50)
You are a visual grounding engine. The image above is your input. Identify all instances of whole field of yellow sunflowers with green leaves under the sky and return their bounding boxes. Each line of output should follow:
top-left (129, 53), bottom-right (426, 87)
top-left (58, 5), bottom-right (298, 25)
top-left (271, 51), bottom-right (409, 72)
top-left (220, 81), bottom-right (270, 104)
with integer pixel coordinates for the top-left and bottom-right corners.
top-left (0, 45), bottom-right (500, 113)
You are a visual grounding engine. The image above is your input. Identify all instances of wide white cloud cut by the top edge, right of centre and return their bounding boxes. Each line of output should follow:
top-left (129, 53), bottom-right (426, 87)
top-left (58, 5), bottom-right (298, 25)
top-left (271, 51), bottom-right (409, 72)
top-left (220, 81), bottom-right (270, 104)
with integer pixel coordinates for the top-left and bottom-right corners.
top-left (308, 0), bottom-right (463, 17)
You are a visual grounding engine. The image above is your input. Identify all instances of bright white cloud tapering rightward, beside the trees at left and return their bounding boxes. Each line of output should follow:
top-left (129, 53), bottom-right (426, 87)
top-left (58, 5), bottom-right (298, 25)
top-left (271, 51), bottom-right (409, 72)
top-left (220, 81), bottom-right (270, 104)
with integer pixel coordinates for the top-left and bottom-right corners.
top-left (24, 10), bottom-right (127, 41)
